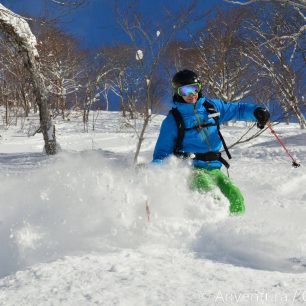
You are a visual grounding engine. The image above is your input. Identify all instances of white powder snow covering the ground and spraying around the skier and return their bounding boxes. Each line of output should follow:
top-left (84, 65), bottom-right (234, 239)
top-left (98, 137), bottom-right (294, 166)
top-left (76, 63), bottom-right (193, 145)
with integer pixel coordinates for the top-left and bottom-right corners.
top-left (0, 112), bottom-right (306, 306)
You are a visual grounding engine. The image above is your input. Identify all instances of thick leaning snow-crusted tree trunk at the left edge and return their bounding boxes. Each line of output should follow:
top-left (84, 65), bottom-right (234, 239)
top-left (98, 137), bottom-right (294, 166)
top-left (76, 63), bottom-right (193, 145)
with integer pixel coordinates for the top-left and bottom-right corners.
top-left (0, 4), bottom-right (57, 154)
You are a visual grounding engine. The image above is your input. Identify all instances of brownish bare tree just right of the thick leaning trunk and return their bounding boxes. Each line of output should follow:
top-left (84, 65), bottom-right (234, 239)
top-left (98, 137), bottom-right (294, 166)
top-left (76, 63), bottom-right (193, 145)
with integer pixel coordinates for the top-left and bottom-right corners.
top-left (38, 25), bottom-right (86, 118)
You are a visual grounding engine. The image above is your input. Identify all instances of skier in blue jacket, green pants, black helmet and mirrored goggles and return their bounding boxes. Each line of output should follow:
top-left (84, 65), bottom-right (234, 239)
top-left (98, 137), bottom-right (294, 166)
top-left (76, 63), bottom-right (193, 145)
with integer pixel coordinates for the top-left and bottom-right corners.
top-left (152, 70), bottom-right (270, 214)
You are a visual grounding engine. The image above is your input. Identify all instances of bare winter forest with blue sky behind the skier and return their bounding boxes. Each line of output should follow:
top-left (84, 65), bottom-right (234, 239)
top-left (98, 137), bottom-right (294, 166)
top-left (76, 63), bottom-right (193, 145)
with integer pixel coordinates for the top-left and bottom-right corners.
top-left (0, 0), bottom-right (306, 160)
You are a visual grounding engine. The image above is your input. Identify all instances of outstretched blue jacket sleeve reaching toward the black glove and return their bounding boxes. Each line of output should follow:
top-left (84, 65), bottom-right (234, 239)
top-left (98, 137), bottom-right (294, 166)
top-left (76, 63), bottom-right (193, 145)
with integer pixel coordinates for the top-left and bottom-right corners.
top-left (212, 100), bottom-right (260, 123)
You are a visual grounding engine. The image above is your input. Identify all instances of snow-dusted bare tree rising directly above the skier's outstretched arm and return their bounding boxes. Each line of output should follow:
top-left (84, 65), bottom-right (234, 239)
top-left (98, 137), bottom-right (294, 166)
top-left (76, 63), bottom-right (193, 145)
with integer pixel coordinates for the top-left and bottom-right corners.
top-left (195, 8), bottom-right (260, 102)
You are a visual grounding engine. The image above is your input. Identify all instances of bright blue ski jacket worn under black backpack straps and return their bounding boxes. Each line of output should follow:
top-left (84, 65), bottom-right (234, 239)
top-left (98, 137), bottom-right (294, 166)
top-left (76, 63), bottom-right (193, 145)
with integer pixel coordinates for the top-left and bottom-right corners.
top-left (152, 97), bottom-right (259, 170)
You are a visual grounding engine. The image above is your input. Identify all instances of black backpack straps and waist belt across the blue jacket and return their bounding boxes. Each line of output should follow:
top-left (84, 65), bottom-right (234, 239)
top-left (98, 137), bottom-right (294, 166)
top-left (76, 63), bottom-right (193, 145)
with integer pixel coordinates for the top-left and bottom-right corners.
top-left (169, 100), bottom-right (232, 169)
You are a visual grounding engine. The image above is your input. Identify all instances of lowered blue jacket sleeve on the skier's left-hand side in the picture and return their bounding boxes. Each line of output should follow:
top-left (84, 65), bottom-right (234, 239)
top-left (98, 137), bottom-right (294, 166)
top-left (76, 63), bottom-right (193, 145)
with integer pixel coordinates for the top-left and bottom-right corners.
top-left (152, 114), bottom-right (177, 163)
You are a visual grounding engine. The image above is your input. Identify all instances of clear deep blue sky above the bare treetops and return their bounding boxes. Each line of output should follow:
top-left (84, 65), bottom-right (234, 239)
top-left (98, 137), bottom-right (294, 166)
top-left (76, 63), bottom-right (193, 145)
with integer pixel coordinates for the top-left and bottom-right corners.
top-left (1, 0), bottom-right (228, 49)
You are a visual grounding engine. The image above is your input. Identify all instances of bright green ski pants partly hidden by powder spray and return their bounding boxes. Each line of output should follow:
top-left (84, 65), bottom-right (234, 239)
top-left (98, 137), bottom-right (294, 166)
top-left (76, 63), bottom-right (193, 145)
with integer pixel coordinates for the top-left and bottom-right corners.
top-left (190, 168), bottom-right (245, 214)
